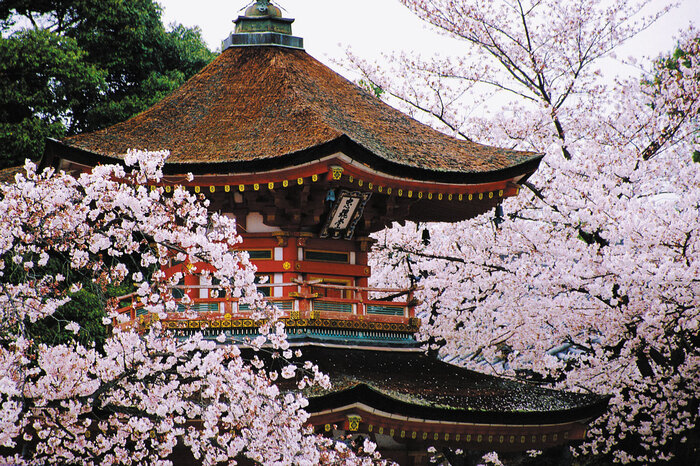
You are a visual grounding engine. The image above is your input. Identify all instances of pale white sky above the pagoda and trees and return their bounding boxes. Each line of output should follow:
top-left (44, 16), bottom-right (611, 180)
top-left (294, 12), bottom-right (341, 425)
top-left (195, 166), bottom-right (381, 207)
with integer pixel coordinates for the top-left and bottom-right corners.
top-left (157, 0), bottom-right (700, 74)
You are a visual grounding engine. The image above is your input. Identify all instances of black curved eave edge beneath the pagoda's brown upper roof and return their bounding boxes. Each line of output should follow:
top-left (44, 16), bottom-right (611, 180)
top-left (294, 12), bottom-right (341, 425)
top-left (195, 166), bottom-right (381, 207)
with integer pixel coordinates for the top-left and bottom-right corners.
top-left (44, 135), bottom-right (543, 184)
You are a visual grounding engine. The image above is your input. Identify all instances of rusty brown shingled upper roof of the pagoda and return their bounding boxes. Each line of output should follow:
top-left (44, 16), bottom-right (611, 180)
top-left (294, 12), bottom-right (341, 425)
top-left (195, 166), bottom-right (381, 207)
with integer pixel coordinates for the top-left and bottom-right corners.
top-left (62, 46), bottom-right (540, 174)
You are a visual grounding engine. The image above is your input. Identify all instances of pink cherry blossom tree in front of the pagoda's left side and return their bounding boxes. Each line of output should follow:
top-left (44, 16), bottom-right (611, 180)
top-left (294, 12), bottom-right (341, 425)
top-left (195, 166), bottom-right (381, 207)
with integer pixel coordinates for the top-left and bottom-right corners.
top-left (0, 152), bottom-right (377, 465)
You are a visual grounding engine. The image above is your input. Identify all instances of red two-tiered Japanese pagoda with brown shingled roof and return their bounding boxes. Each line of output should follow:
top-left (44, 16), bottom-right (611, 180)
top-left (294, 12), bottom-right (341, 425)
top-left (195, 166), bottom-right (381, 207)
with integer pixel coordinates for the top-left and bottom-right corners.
top-left (43, 1), bottom-right (607, 464)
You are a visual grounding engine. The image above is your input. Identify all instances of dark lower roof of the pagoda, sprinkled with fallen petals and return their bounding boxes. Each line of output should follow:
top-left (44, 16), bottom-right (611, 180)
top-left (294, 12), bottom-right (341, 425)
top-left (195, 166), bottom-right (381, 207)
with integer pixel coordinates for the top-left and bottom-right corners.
top-left (302, 346), bottom-right (608, 424)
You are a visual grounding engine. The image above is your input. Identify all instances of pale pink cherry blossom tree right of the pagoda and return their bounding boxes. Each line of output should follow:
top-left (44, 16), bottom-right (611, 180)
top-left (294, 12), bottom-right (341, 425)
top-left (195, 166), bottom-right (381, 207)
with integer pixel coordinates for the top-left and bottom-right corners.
top-left (350, 0), bottom-right (700, 464)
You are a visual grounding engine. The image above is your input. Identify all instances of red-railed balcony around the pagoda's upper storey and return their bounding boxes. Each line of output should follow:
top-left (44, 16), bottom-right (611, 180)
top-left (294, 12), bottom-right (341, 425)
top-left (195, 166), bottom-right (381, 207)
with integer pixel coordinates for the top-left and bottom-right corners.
top-left (115, 281), bottom-right (420, 342)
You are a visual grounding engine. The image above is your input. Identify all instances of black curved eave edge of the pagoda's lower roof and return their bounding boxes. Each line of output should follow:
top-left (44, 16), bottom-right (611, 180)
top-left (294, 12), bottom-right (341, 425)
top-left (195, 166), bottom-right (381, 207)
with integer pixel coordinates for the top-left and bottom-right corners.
top-left (306, 384), bottom-right (609, 426)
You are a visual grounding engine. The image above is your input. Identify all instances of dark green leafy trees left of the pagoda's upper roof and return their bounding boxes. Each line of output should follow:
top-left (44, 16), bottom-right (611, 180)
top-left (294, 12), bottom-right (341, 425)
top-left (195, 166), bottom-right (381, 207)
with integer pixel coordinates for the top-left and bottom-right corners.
top-left (0, 0), bottom-right (215, 169)
